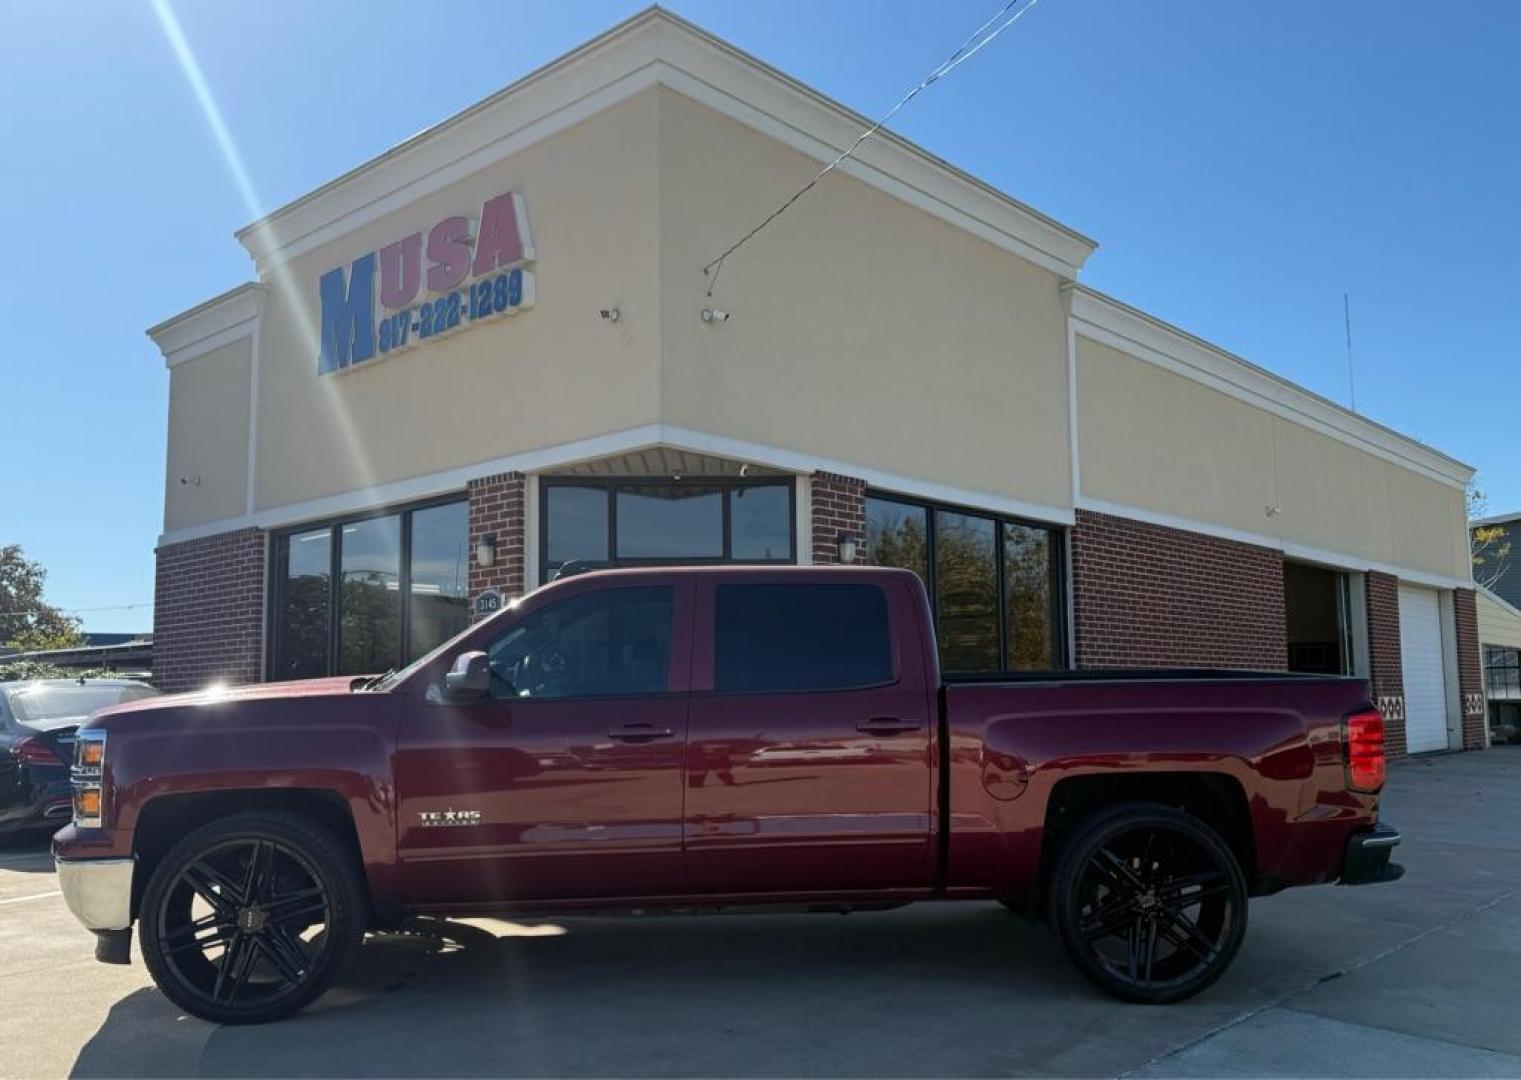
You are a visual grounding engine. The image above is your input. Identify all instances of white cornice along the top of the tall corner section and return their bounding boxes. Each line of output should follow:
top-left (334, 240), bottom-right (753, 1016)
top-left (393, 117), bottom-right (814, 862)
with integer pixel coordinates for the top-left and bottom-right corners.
top-left (237, 8), bottom-right (1097, 278)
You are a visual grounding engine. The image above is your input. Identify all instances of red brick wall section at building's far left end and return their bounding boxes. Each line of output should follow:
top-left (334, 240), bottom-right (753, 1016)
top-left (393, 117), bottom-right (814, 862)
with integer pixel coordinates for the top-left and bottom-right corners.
top-left (154, 529), bottom-right (268, 694)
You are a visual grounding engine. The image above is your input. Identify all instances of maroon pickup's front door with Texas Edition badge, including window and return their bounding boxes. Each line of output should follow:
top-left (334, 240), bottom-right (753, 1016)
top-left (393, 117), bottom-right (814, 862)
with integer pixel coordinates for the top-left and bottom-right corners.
top-left (395, 575), bottom-right (692, 904)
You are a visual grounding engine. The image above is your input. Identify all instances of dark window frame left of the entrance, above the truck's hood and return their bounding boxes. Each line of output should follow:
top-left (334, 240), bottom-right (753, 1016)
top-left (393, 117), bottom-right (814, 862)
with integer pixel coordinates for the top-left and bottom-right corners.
top-left (263, 491), bottom-right (473, 681)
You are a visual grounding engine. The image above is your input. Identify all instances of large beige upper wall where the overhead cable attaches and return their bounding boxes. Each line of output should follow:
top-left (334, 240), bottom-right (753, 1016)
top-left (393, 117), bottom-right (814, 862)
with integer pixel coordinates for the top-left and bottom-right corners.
top-left (660, 90), bottom-right (1071, 507)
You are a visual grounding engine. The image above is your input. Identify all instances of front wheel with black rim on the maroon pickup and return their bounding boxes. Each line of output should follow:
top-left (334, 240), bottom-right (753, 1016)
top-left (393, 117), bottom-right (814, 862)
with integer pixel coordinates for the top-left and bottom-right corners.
top-left (138, 811), bottom-right (368, 1024)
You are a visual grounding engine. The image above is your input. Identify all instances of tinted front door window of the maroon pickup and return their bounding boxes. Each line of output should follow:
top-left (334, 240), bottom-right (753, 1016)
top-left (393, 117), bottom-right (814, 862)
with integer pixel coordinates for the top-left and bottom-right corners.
top-left (487, 586), bottom-right (674, 698)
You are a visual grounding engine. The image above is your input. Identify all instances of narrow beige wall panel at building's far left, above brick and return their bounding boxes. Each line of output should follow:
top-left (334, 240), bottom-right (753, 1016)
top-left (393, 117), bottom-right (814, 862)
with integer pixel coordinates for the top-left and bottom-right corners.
top-left (164, 338), bottom-right (252, 531)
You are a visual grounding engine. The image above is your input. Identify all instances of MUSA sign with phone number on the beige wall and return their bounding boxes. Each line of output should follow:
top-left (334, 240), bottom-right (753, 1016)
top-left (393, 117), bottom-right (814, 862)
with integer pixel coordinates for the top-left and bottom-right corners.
top-left (316, 192), bottom-right (534, 374)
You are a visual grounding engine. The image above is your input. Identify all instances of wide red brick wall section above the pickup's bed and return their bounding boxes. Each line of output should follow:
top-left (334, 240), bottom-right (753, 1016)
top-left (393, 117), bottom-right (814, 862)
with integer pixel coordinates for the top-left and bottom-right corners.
top-left (1072, 510), bottom-right (1288, 669)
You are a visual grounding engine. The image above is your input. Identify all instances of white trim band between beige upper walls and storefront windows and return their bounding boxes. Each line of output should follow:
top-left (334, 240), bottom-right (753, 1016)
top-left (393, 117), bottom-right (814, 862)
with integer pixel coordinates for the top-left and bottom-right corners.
top-left (158, 424), bottom-right (1072, 546)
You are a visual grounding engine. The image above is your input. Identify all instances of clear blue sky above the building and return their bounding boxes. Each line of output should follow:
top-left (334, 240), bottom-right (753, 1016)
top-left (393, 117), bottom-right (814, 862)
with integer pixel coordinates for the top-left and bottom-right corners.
top-left (0, 0), bottom-right (1521, 630)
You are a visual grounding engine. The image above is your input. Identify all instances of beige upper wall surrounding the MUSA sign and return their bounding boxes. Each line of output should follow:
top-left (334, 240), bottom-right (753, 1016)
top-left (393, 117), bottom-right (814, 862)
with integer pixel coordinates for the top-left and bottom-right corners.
top-left (257, 90), bottom-right (659, 508)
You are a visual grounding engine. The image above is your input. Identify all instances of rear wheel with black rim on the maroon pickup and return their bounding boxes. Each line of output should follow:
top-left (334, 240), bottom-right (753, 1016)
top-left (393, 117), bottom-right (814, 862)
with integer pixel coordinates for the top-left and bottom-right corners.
top-left (1049, 803), bottom-right (1247, 1004)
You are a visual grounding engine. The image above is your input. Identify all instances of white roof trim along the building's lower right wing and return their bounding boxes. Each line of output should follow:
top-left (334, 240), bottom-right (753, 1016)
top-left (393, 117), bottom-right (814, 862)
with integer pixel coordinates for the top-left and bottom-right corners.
top-left (1071, 284), bottom-right (1474, 488)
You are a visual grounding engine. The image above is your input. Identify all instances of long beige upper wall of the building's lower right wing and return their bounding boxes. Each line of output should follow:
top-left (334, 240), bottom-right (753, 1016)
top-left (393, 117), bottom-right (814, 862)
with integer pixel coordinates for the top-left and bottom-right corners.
top-left (1077, 336), bottom-right (1468, 580)
